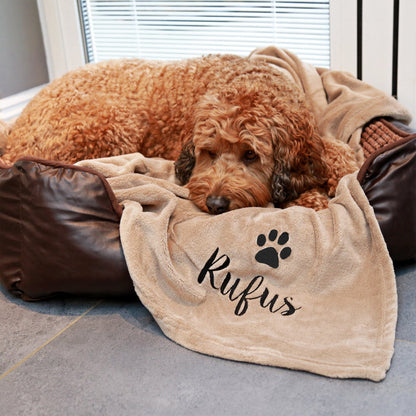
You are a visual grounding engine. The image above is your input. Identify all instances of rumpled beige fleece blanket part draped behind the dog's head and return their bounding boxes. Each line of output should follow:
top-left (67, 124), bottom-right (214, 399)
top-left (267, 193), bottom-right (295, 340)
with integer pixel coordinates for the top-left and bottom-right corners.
top-left (249, 46), bottom-right (412, 163)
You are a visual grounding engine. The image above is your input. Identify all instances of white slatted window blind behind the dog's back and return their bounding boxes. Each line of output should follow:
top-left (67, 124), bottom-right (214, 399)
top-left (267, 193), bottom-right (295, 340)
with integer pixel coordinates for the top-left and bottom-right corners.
top-left (78, 0), bottom-right (330, 67)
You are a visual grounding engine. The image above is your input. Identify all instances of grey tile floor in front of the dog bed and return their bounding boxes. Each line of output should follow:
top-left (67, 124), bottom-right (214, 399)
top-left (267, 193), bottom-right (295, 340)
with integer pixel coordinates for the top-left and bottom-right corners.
top-left (0, 263), bottom-right (416, 416)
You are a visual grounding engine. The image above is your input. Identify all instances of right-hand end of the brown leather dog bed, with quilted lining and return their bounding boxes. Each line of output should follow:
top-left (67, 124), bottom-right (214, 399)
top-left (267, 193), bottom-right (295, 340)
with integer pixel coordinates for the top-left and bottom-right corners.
top-left (358, 119), bottom-right (416, 261)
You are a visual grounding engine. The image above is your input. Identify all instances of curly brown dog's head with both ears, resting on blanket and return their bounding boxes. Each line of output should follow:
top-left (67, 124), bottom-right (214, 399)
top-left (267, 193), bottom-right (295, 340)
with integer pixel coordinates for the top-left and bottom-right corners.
top-left (175, 84), bottom-right (326, 214)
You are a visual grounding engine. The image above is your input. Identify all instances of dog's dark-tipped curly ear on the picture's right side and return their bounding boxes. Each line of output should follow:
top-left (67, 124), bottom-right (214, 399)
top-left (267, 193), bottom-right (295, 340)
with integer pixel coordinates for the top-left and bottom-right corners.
top-left (271, 110), bottom-right (328, 206)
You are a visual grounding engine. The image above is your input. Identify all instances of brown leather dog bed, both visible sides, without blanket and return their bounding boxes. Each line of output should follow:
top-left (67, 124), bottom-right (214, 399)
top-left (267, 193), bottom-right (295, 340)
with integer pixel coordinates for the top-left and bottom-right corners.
top-left (0, 119), bottom-right (416, 300)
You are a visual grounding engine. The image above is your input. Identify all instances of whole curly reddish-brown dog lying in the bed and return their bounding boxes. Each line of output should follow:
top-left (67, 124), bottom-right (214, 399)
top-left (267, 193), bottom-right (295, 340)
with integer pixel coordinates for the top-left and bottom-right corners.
top-left (0, 55), bottom-right (357, 214)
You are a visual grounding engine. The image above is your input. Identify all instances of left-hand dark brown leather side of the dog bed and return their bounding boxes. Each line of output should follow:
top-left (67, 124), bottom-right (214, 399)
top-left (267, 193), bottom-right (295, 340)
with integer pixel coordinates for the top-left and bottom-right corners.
top-left (0, 158), bottom-right (134, 300)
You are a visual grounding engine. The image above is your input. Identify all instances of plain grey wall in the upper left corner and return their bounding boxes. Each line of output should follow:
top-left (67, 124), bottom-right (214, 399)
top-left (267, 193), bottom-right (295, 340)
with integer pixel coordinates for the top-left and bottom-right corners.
top-left (0, 0), bottom-right (49, 98)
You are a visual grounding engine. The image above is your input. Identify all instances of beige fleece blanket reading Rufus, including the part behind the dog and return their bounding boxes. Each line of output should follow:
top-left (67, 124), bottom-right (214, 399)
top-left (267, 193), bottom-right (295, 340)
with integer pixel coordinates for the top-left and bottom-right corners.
top-left (76, 48), bottom-right (409, 380)
